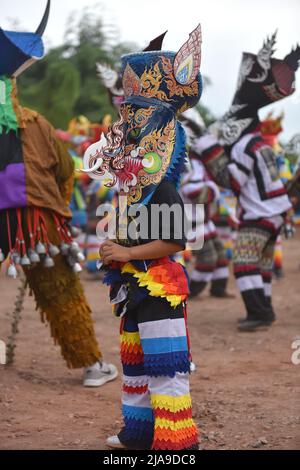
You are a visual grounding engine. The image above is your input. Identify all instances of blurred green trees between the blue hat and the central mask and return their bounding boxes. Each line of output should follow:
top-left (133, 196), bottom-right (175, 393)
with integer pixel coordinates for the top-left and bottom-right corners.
top-left (18, 5), bottom-right (133, 129)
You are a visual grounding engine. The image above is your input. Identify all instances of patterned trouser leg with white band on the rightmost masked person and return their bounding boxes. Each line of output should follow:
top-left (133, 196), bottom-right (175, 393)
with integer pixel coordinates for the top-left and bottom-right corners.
top-left (233, 224), bottom-right (273, 322)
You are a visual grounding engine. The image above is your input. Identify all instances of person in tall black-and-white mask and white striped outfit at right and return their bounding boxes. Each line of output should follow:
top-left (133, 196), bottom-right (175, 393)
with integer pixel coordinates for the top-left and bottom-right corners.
top-left (191, 34), bottom-right (300, 331)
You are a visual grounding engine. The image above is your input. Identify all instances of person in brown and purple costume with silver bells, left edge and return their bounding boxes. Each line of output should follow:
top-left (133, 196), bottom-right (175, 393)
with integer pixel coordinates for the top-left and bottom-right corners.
top-left (0, 1), bottom-right (117, 386)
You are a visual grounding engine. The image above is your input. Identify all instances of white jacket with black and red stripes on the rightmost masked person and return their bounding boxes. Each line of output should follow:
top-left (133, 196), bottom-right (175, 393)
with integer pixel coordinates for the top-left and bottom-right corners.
top-left (196, 133), bottom-right (291, 220)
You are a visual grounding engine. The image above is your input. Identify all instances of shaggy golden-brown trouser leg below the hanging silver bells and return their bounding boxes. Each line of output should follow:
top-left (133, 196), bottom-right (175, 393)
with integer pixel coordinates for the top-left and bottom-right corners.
top-left (24, 218), bottom-right (101, 368)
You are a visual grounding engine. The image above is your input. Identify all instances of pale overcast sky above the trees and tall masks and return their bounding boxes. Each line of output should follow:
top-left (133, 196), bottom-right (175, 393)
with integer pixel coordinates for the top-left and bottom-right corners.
top-left (0, 0), bottom-right (300, 140)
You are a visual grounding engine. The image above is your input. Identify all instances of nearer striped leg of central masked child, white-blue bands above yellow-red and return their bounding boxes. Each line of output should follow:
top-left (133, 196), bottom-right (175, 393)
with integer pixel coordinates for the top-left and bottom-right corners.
top-left (137, 297), bottom-right (198, 450)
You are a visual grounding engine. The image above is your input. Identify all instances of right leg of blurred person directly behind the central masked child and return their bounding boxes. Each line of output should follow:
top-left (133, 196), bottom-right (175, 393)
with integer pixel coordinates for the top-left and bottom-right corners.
top-left (210, 237), bottom-right (229, 297)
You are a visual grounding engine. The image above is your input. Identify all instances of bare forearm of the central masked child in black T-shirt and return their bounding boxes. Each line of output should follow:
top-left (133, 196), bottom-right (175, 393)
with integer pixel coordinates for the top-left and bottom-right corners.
top-left (128, 240), bottom-right (182, 260)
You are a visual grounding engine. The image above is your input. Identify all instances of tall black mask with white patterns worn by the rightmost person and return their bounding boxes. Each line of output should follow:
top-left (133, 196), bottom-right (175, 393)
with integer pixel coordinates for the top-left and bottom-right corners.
top-left (213, 33), bottom-right (300, 146)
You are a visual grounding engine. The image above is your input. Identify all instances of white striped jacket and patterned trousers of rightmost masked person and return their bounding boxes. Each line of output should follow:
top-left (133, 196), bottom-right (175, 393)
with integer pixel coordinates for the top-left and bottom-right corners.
top-left (196, 134), bottom-right (291, 321)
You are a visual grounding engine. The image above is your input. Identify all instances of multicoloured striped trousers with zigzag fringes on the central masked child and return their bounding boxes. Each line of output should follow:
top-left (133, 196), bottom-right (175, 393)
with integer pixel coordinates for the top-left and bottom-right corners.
top-left (119, 297), bottom-right (198, 450)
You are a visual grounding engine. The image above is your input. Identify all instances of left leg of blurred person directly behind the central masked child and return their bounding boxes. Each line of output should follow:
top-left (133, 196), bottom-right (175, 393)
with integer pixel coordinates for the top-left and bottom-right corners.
top-left (190, 239), bottom-right (217, 298)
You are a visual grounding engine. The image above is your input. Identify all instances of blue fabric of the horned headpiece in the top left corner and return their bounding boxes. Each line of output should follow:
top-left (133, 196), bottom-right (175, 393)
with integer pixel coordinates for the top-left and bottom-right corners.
top-left (0, 29), bottom-right (44, 76)
